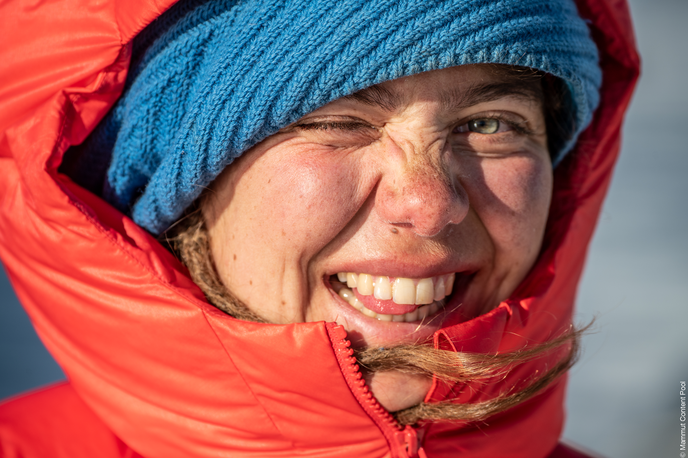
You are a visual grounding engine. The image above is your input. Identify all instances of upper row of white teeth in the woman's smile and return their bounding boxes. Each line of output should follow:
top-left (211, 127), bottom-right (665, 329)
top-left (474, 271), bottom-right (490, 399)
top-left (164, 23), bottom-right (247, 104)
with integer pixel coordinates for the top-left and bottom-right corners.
top-left (337, 272), bottom-right (455, 305)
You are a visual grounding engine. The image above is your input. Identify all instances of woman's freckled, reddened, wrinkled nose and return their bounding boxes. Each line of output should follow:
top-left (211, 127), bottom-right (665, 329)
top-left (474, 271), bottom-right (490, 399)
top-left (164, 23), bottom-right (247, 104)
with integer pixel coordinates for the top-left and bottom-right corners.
top-left (375, 138), bottom-right (468, 237)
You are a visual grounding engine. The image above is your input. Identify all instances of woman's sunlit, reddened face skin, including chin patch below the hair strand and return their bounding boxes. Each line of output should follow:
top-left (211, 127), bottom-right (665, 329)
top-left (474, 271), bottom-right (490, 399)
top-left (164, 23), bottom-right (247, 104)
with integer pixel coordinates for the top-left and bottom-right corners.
top-left (202, 65), bottom-right (552, 411)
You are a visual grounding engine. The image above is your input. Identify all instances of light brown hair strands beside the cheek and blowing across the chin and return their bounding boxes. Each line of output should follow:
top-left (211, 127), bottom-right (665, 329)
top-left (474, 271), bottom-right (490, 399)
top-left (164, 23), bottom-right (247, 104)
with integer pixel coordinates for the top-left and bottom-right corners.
top-left (162, 209), bottom-right (590, 425)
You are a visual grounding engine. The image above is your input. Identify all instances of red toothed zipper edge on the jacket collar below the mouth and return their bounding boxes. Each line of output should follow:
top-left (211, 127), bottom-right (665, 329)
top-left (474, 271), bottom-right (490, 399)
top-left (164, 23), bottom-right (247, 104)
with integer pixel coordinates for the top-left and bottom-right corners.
top-left (326, 323), bottom-right (426, 458)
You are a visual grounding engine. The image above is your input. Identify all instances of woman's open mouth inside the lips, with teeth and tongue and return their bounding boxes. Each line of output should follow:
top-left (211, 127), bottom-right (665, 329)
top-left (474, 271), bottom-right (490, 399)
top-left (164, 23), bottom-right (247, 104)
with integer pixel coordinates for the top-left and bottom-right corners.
top-left (331, 272), bottom-right (455, 322)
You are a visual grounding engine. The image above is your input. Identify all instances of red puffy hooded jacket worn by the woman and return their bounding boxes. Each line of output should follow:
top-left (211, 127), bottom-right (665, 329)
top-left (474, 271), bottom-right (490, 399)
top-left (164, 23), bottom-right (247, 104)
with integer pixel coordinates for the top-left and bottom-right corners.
top-left (0, 0), bottom-right (639, 458)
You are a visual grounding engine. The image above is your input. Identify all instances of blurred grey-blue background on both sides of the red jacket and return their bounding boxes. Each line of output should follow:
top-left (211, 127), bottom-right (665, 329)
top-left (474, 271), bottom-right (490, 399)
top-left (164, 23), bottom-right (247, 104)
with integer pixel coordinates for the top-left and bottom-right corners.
top-left (0, 0), bottom-right (688, 458)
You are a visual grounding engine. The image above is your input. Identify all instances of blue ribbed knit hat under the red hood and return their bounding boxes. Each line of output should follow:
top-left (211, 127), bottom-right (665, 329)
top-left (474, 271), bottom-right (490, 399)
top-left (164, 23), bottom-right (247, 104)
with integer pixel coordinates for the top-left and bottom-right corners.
top-left (77, 0), bottom-right (601, 235)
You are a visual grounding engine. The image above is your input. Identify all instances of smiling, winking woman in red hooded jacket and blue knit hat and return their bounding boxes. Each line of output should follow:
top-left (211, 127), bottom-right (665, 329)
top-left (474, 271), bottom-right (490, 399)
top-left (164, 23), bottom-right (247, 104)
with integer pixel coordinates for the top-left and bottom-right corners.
top-left (0, 0), bottom-right (636, 458)
